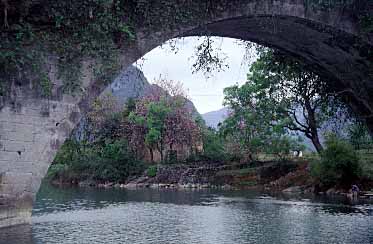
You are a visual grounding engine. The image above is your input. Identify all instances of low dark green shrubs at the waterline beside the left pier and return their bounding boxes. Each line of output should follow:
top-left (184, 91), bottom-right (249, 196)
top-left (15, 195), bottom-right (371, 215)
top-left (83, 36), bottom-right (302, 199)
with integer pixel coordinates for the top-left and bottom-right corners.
top-left (48, 140), bottom-right (144, 182)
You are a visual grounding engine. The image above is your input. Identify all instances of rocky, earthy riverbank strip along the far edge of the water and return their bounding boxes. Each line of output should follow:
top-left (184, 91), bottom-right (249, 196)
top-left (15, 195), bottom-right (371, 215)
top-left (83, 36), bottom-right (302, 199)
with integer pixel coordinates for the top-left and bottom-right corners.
top-left (51, 159), bottom-right (373, 199)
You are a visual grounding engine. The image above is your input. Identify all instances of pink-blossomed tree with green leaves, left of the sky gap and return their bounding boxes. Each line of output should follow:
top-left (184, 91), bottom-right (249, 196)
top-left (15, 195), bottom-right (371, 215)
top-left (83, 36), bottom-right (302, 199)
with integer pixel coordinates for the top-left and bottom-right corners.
top-left (129, 79), bottom-right (200, 161)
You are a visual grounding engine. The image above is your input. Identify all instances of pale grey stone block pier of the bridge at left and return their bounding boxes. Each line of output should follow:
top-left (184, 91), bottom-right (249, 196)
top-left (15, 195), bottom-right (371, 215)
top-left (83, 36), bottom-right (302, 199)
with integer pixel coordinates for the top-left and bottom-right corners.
top-left (0, 99), bottom-right (80, 227)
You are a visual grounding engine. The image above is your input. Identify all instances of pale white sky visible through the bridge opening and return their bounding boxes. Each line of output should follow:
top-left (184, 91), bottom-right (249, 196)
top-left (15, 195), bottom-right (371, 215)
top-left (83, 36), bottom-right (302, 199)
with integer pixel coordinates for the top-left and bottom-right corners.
top-left (135, 37), bottom-right (255, 114)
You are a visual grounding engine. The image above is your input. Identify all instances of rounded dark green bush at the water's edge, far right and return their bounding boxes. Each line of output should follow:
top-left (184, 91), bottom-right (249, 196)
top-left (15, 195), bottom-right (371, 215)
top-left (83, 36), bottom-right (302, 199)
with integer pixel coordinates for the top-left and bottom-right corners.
top-left (311, 136), bottom-right (361, 187)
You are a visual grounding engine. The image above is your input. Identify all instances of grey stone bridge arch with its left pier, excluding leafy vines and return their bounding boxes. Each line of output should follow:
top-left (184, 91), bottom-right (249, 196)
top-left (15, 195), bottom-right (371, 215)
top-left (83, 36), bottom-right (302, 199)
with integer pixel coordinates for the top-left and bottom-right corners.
top-left (0, 0), bottom-right (373, 227)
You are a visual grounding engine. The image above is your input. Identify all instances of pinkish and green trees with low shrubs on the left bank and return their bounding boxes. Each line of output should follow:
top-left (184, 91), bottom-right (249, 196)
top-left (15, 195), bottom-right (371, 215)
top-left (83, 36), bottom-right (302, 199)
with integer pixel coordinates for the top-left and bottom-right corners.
top-left (48, 80), bottom-right (204, 183)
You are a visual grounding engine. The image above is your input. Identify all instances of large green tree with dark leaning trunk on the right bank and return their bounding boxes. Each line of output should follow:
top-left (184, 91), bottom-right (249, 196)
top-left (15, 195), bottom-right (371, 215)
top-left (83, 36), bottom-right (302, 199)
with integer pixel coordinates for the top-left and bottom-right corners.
top-left (225, 50), bottom-right (337, 152)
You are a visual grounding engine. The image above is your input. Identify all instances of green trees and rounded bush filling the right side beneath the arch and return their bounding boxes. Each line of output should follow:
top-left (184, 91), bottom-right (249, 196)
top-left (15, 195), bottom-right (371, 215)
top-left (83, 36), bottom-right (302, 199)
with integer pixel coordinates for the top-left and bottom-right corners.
top-left (220, 49), bottom-right (373, 189)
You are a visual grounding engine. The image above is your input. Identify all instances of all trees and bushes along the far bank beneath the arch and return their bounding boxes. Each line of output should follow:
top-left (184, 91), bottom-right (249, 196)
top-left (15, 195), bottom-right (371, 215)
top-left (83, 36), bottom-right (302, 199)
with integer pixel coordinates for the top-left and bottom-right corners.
top-left (48, 49), bottom-right (373, 193)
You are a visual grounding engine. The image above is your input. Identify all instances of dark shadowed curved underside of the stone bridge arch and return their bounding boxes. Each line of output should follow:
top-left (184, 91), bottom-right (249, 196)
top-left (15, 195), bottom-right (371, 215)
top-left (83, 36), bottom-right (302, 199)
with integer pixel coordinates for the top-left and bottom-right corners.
top-left (184, 16), bottom-right (373, 127)
